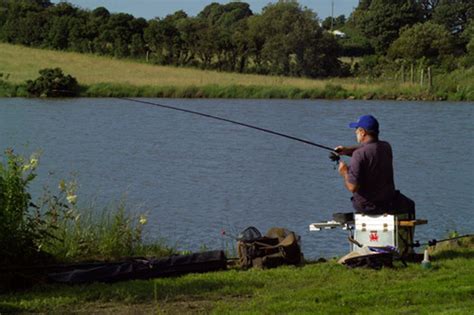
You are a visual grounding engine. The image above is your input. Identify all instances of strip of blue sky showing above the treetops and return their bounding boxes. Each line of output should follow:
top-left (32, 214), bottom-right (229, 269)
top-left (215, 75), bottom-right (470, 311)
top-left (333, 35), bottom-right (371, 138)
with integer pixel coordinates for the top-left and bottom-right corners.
top-left (51, 0), bottom-right (359, 20)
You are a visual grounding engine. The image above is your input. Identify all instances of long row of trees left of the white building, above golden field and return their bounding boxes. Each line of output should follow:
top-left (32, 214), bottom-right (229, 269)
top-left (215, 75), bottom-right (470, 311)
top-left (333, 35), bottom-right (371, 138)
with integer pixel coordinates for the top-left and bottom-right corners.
top-left (0, 0), bottom-right (343, 77)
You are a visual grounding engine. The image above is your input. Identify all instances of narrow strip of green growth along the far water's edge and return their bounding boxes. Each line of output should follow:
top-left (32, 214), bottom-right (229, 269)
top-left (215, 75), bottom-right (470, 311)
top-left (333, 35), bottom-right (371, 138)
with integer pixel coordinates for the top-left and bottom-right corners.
top-left (0, 83), bottom-right (474, 101)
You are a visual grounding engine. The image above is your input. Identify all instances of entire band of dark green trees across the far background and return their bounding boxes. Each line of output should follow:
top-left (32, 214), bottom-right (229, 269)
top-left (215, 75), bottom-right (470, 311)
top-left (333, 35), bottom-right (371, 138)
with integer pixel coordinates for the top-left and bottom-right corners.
top-left (0, 0), bottom-right (474, 78)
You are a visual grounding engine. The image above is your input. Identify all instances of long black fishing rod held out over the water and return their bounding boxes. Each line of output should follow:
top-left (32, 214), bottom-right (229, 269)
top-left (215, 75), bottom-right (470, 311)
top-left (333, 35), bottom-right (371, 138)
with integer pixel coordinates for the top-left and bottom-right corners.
top-left (118, 97), bottom-right (339, 162)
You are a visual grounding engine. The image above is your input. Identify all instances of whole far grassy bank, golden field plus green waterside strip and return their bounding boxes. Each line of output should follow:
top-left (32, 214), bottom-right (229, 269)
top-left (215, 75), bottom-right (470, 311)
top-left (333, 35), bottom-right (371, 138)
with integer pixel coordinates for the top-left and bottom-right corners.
top-left (0, 43), bottom-right (474, 101)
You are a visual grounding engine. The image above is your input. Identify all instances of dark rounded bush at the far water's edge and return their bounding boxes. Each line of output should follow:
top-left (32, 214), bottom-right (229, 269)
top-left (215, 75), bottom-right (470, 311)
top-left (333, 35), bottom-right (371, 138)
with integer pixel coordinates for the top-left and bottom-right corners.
top-left (26, 68), bottom-right (79, 97)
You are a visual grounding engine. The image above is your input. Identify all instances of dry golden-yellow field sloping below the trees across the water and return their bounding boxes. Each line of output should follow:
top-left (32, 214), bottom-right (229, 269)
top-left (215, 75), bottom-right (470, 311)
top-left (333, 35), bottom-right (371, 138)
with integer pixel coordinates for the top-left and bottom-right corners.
top-left (0, 43), bottom-right (340, 88)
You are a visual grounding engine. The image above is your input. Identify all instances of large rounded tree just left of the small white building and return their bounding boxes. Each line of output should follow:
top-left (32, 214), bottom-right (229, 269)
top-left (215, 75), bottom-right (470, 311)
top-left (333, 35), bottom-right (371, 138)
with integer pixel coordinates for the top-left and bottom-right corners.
top-left (254, 1), bottom-right (340, 77)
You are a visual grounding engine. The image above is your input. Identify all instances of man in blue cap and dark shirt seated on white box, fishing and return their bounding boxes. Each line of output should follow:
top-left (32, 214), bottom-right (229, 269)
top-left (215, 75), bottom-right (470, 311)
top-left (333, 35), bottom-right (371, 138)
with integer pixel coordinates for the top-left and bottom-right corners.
top-left (334, 115), bottom-right (415, 217)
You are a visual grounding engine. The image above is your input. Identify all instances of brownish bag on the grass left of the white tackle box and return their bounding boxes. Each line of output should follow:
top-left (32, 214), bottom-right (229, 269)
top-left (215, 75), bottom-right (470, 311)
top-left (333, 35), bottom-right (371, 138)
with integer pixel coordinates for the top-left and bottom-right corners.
top-left (237, 227), bottom-right (302, 269)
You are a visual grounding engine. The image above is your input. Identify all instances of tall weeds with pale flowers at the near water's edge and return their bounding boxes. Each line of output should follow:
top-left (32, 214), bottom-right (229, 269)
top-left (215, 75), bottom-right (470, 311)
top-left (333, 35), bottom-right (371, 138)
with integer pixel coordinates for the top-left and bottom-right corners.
top-left (0, 149), bottom-right (173, 266)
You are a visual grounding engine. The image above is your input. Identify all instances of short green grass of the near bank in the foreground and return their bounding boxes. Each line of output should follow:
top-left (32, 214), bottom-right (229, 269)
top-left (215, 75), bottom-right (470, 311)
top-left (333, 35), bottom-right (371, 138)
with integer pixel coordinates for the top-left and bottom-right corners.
top-left (0, 239), bottom-right (474, 314)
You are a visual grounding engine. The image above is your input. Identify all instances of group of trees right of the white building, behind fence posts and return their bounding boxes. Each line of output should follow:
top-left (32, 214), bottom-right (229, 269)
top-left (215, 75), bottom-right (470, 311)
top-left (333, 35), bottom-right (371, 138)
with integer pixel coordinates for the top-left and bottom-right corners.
top-left (345, 0), bottom-right (474, 71)
